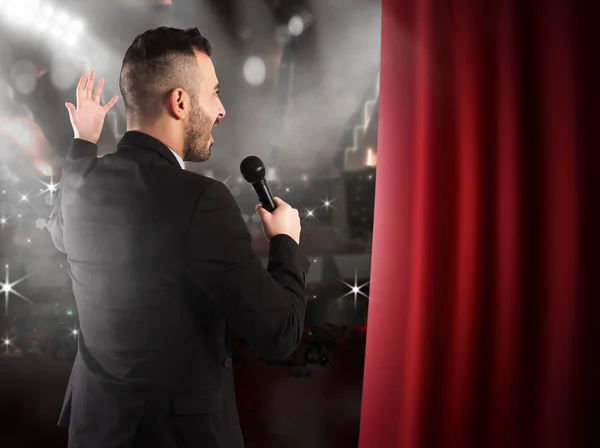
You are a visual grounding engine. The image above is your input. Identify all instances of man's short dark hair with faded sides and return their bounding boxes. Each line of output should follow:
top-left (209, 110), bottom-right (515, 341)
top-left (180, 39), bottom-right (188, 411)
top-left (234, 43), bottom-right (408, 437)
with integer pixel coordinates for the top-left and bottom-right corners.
top-left (119, 27), bottom-right (212, 124)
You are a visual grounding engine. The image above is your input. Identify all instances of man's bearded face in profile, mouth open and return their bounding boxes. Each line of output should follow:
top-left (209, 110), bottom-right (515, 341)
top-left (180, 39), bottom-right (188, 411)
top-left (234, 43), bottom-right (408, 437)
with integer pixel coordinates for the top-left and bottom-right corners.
top-left (183, 52), bottom-right (225, 162)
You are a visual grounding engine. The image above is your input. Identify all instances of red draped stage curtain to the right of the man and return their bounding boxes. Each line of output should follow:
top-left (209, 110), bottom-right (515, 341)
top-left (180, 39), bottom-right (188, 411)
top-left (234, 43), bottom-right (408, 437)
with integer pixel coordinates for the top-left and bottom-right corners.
top-left (360, 0), bottom-right (600, 448)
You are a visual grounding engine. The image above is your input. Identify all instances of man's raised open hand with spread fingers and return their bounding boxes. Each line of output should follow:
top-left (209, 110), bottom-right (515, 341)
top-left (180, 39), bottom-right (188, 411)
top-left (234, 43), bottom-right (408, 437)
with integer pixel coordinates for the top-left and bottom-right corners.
top-left (65, 70), bottom-right (119, 143)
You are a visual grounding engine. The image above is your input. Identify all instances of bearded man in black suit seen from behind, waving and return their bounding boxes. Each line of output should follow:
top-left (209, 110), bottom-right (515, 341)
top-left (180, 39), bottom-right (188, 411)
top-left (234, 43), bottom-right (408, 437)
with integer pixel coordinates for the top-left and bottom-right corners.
top-left (50, 28), bottom-right (310, 448)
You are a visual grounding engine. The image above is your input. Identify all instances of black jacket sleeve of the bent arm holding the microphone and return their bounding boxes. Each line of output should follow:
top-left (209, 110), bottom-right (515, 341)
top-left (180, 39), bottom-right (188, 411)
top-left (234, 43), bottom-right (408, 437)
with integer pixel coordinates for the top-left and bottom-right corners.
top-left (187, 182), bottom-right (310, 359)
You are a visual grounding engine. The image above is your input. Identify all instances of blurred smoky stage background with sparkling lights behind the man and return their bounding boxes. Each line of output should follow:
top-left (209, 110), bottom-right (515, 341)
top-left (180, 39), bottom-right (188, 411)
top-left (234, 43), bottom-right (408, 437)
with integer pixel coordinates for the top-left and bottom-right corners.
top-left (0, 0), bottom-right (381, 448)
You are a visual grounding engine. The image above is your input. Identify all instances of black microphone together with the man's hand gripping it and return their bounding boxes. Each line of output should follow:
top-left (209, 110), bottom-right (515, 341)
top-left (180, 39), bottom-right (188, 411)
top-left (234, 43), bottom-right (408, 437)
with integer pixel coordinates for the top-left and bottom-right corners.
top-left (240, 156), bottom-right (302, 244)
